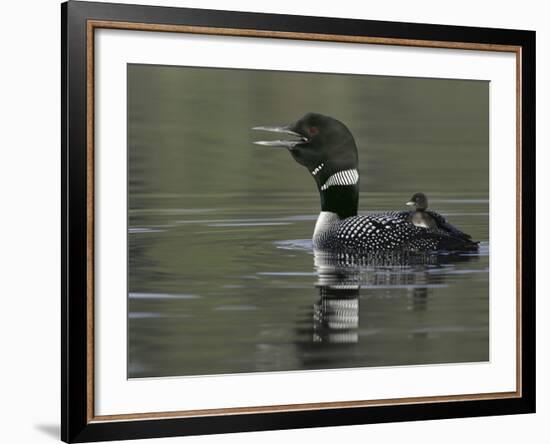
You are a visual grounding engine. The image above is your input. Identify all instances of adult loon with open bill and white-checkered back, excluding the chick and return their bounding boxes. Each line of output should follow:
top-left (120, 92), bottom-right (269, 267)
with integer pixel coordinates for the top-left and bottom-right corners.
top-left (253, 113), bottom-right (477, 252)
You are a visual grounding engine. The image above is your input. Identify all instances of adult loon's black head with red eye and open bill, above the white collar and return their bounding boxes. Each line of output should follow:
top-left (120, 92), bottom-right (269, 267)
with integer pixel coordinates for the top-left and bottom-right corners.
top-left (253, 113), bottom-right (357, 188)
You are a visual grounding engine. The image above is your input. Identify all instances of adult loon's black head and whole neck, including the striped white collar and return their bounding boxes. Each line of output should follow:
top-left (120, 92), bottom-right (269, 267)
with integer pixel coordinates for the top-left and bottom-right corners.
top-left (253, 113), bottom-right (359, 217)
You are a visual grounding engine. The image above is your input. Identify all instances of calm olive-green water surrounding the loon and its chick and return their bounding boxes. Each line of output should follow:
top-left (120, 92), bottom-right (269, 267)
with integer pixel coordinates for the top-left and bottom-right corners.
top-left (128, 65), bottom-right (489, 377)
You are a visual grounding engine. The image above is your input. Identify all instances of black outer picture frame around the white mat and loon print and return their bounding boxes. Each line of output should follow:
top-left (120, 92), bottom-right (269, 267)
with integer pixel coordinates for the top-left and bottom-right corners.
top-left (61, 1), bottom-right (535, 442)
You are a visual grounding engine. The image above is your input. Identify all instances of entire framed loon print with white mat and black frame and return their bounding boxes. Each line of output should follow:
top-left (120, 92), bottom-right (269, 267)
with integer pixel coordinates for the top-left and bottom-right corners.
top-left (61, 1), bottom-right (535, 442)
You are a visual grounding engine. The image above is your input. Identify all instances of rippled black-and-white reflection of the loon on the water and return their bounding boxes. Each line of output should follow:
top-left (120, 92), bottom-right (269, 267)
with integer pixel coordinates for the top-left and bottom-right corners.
top-left (296, 251), bottom-right (477, 366)
